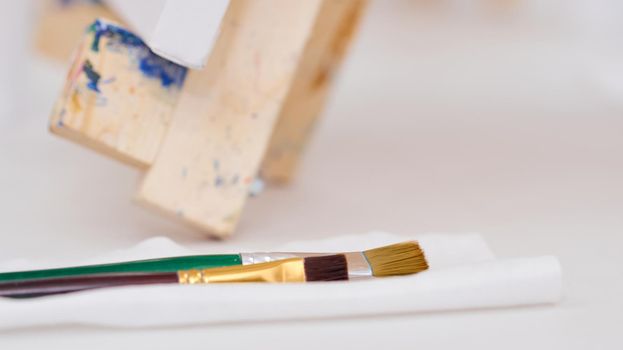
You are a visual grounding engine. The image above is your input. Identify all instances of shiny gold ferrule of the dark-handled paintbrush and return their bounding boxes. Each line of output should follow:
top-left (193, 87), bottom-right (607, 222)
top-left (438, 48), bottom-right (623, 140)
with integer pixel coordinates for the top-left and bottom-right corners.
top-left (177, 258), bottom-right (305, 284)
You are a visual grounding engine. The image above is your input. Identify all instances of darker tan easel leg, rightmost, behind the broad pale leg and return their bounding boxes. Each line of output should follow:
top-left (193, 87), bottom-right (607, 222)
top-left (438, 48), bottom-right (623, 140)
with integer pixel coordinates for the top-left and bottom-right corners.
top-left (261, 0), bottom-right (366, 183)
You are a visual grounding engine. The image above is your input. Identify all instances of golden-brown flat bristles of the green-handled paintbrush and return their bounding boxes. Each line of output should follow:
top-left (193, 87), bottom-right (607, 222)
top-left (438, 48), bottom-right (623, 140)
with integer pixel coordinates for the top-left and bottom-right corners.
top-left (363, 241), bottom-right (428, 277)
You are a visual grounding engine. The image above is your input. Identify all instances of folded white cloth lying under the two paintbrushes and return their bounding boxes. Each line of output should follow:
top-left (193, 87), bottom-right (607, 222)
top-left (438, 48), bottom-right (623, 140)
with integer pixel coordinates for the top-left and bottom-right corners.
top-left (0, 232), bottom-right (562, 329)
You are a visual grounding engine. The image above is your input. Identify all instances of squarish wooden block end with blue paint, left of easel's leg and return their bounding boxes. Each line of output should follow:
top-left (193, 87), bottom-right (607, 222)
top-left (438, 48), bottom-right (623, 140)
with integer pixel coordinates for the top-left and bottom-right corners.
top-left (50, 21), bottom-right (186, 168)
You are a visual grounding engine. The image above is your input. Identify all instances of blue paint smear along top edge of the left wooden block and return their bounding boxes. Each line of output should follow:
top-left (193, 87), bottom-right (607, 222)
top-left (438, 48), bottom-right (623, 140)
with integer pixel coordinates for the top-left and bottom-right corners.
top-left (88, 20), bottom-right (188, 88)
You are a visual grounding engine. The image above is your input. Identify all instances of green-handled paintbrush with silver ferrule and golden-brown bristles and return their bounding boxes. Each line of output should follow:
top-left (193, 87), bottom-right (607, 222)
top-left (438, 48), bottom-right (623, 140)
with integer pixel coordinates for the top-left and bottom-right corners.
top-left (0, 241), bottom-right (428, 282)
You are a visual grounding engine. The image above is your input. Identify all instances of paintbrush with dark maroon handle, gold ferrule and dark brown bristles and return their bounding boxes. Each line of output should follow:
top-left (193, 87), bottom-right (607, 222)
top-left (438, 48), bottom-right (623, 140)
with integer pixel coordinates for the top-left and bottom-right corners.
top-left (0, 254), bottom-right (348, 298)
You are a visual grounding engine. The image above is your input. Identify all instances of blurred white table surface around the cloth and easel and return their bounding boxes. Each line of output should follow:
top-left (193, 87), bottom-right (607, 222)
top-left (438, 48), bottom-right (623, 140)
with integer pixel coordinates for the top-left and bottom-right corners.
top-left (0, 1), bottom-right (623, 349)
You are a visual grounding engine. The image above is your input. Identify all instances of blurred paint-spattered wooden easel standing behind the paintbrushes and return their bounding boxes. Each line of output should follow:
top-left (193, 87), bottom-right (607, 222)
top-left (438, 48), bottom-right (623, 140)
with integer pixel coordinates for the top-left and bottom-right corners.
top-left (50, 0), bottom-right (365, 237)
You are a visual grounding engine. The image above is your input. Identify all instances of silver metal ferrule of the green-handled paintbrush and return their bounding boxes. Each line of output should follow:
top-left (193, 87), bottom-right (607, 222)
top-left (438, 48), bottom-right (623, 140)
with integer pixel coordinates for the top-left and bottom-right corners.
top-left (240, 252), bottom-right (373, 280)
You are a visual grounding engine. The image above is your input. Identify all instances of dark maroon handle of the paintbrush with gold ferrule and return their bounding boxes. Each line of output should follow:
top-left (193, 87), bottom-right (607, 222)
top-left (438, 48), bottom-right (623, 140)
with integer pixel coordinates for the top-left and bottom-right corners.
top-left (0, 272), bottom-right (178, 298)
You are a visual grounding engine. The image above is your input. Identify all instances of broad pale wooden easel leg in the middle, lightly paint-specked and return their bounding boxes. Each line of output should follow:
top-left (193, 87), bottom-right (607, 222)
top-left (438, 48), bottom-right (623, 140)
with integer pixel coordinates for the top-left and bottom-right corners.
top-left (137, 0), bottom-right (329, 237)
